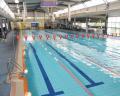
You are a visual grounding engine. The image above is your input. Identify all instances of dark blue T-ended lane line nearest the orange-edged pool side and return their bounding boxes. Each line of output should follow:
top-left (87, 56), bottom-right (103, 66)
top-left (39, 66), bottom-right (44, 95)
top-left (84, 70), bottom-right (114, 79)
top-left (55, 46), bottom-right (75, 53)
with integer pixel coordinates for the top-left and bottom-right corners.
top-left (29, 43), bottom-right (64, 96)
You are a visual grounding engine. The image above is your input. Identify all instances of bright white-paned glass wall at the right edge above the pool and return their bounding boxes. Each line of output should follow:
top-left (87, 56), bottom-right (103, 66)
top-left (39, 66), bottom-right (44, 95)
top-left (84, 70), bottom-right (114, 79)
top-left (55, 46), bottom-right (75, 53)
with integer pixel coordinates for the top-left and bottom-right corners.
top-left (107, 17), bottom-right (120, 36)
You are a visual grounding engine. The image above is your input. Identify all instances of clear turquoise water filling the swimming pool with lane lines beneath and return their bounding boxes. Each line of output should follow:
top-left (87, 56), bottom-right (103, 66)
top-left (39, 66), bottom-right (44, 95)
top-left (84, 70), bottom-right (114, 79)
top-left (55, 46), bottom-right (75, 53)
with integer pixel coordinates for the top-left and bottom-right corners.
top-left (25, 30), bottom-right (120, 96)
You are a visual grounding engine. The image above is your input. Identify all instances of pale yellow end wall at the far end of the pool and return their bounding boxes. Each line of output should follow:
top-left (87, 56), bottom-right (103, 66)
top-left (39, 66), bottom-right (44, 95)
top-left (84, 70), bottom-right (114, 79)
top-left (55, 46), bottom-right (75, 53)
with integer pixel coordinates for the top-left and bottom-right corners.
top-left (11, 11), bottom-right (48, 30)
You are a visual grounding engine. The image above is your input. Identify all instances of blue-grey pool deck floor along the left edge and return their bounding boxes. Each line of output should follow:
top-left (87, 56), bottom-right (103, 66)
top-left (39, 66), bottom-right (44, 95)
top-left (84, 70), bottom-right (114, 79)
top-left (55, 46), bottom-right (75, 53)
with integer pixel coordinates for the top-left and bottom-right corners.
top-left (0, 41), bottom-right (13, 96)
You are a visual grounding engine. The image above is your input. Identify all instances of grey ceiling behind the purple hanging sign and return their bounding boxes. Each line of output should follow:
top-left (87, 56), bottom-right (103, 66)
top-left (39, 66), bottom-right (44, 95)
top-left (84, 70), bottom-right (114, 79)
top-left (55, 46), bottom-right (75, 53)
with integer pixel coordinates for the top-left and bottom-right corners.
top-left (5, 0), bottom-right (89, 13)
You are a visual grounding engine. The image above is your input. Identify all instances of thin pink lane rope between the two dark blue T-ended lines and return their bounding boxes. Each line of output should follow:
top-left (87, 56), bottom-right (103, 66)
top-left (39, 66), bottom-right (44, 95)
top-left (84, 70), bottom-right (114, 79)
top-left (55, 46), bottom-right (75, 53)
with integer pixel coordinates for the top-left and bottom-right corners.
top-left (58, 61), bottom-right (94, 96)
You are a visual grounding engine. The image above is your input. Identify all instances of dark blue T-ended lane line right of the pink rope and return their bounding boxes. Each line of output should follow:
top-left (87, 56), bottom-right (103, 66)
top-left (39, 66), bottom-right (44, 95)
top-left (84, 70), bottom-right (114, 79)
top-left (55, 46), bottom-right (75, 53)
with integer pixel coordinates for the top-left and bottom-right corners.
top-left (46, 42), bottom-right (104, 88)
